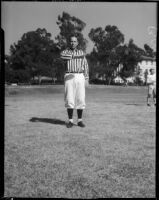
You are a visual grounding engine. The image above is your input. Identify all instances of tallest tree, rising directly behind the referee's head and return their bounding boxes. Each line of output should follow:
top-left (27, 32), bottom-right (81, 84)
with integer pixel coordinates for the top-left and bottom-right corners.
top-left (55, 12), bottom-right (87, 51)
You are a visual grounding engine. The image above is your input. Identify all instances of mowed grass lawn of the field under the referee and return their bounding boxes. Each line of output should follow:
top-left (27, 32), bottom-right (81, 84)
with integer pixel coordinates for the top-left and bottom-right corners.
top-left (4, 85), bottom-right (156, 199)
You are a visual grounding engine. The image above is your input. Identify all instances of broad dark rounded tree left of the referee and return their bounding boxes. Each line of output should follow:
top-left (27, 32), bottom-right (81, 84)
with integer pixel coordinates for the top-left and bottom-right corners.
top-left (7, 28), bottom-right (59, 83)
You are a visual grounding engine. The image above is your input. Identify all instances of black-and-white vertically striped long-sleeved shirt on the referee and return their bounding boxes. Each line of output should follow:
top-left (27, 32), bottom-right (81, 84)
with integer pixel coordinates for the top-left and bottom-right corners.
top-left (61, 49), bottom-right (89, 78)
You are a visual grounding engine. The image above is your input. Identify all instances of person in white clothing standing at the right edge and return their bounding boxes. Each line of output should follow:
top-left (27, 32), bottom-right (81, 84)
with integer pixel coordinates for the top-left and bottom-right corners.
top-left (147, 68), bottom-right (156, 106)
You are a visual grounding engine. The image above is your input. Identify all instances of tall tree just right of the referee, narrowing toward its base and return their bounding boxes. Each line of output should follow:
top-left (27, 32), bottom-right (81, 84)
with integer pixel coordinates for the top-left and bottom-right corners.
top-left (88, 25), bottom-right (124, 84)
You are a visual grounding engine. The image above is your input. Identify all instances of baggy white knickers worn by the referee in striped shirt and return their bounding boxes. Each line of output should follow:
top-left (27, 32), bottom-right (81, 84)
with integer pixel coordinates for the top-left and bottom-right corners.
top-left (64, 73), bottom-right (85, 109)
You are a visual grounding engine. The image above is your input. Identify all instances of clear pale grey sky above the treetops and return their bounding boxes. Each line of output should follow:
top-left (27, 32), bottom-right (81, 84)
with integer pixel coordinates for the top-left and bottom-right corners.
top-left (1, 1), bottom-right (157, 54)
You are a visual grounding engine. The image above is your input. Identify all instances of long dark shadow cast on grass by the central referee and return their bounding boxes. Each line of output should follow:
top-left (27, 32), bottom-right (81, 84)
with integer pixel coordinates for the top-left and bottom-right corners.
top-left (29, 117), bottom-right (65, 125)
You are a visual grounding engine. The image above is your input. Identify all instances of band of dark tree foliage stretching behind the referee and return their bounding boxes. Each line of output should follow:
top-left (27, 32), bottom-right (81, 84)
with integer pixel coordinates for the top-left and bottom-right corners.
top-left (5, 12), bottom-right (156, 84)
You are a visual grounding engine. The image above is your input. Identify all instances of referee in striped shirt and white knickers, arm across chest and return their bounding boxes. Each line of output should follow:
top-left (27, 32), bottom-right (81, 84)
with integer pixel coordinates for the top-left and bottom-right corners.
top-left (61, 35), bottom-right (89, 128)
